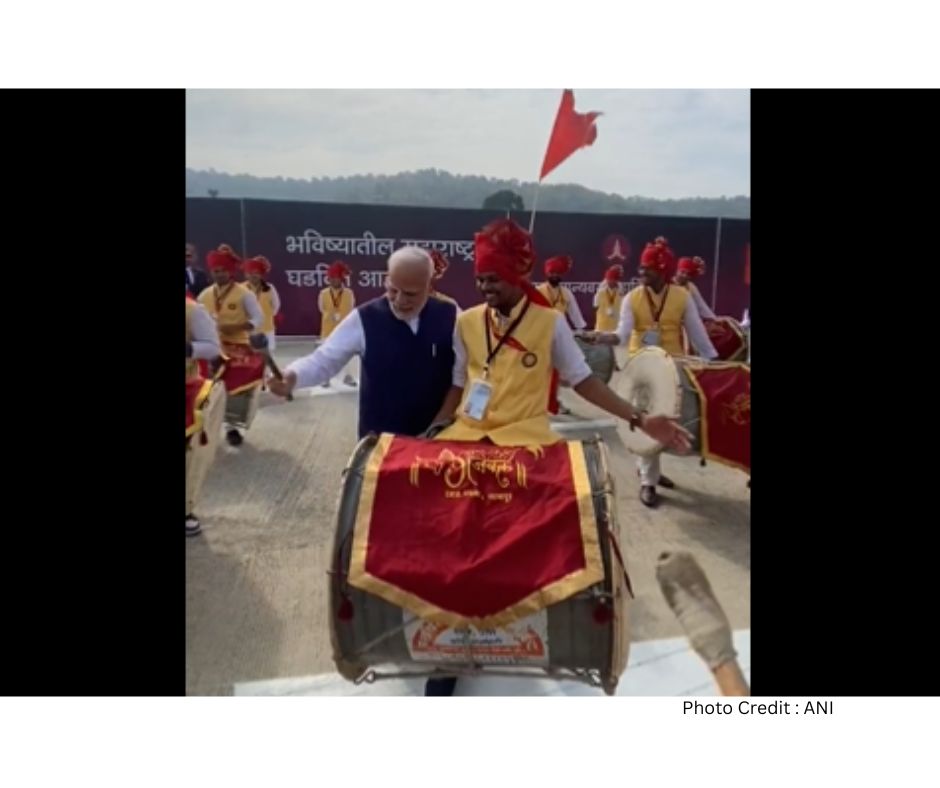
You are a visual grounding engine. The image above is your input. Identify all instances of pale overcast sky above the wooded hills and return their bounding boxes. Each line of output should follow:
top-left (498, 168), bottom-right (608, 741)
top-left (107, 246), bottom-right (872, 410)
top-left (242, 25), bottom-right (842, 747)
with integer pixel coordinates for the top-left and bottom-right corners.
top-left (186, 89), bottom-right (751, 198)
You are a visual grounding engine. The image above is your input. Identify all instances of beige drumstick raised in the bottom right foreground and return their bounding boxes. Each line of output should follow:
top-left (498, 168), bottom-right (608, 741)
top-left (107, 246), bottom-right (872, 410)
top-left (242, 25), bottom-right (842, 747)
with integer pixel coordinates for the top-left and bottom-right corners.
top-left (656, 552), bottom-right (751, 695)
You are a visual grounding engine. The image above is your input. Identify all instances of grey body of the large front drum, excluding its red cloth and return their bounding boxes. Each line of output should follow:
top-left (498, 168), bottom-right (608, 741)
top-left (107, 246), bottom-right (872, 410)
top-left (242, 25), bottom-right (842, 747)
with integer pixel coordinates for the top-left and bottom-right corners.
top-left (329, 435), bottom-right (630, 695)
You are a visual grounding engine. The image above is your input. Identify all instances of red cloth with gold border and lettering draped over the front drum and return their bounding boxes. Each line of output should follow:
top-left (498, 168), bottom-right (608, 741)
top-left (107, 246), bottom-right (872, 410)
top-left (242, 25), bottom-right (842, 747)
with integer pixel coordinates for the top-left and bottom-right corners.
top-left (349, 435), bottom-right (603, 629)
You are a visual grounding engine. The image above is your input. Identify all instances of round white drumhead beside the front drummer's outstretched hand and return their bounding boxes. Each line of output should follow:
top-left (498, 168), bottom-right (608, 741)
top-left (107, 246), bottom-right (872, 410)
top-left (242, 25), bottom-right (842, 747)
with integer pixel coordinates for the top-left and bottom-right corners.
top-left (614, 347), bottom-right (682, 457)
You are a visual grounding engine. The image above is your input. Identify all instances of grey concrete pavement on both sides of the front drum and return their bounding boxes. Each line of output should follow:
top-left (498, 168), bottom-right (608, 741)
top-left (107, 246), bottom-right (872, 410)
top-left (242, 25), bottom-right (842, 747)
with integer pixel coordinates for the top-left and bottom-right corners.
top-left (187, 341), bottom-right (750, 695)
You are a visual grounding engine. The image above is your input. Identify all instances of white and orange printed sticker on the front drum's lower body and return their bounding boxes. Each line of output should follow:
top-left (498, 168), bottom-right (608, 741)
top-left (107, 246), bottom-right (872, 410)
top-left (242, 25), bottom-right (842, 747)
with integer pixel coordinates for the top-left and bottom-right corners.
top-left (404, 610), bottom-right (548, 666)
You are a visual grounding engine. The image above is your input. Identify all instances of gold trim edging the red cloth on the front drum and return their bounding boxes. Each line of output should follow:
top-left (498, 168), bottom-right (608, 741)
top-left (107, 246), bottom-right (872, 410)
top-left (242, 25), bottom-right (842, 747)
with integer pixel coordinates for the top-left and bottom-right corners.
top-left (349, 434), bottom-right (604, 629)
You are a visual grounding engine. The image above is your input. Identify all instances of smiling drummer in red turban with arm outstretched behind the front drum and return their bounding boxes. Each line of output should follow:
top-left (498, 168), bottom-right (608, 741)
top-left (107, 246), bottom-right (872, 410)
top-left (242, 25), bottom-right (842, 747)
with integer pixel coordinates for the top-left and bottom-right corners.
top-left (435, 219), bottom-right (689, 451)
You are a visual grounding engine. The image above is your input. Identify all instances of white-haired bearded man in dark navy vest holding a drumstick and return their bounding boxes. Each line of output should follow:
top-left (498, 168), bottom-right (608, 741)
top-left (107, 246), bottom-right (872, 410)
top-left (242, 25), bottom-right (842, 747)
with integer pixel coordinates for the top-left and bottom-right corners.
top-left (268, 246), bottom-right (457, 437)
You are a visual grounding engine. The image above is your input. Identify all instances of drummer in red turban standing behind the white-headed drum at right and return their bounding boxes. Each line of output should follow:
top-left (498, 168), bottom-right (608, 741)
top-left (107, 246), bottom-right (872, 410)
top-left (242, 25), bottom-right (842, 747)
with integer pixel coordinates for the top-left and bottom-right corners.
top-left (594, 236), bottom-right (718, 506)
